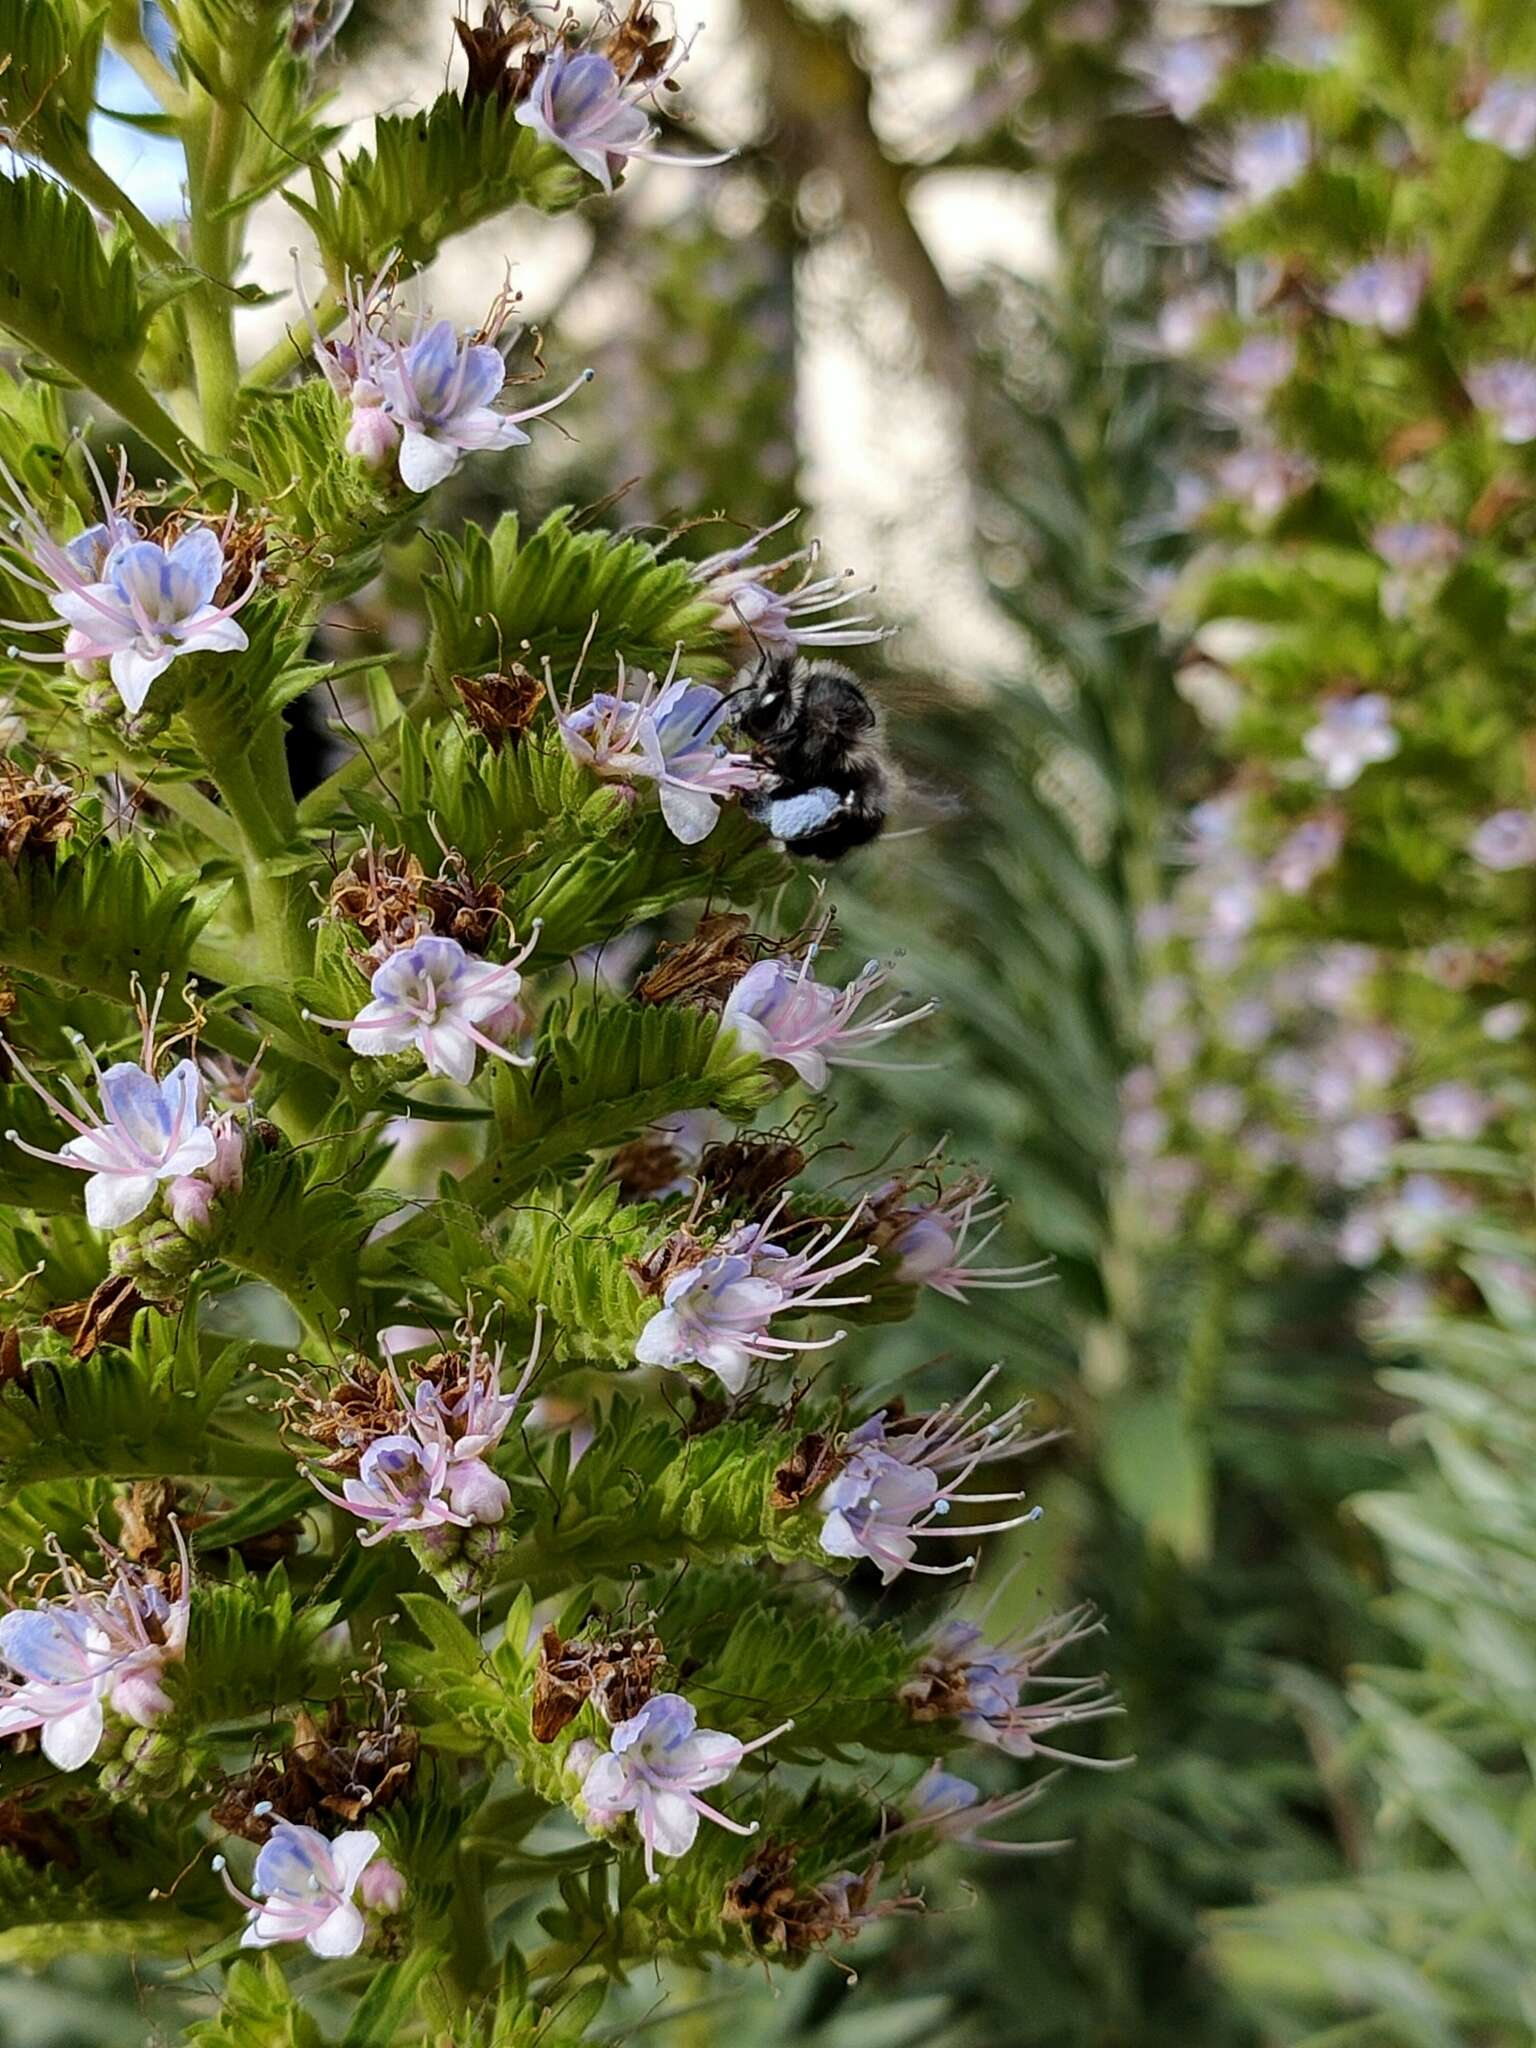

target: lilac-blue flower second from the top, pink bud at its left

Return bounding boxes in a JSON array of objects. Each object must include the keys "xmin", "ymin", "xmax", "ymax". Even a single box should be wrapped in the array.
[{"xmin": 376, "ymin": 319, "xmax": 594, "ymax": 492}]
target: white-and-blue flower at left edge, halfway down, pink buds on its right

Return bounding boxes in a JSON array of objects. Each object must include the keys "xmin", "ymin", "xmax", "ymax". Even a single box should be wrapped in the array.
[{"xmin": 6, "ymin": 1049, "xmax": 219, "ymax": 1231}]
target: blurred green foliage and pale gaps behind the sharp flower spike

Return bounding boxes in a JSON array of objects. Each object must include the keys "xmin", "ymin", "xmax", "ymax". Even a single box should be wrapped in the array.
[{"xmin": 12, "ymin": 0, "xmax": 1536, "ymax": 2048}]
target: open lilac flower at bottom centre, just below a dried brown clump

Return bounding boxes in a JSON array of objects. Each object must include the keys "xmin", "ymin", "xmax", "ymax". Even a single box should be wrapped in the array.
[{"xmin": 582, "ymin": 1692, "xmax": 795, "ymax": 1880}]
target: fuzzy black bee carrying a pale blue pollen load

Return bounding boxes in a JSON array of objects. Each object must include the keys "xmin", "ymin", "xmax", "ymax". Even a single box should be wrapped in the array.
[{"xmin": 733, "ymin": 655, "xmax": 891, "ymax": 860}]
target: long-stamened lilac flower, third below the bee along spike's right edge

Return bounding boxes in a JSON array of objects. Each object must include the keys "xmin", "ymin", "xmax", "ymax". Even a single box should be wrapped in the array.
[{"xmin": 817, "ymin": 1366, "xmax": 1042, "ymax": 1585}]
